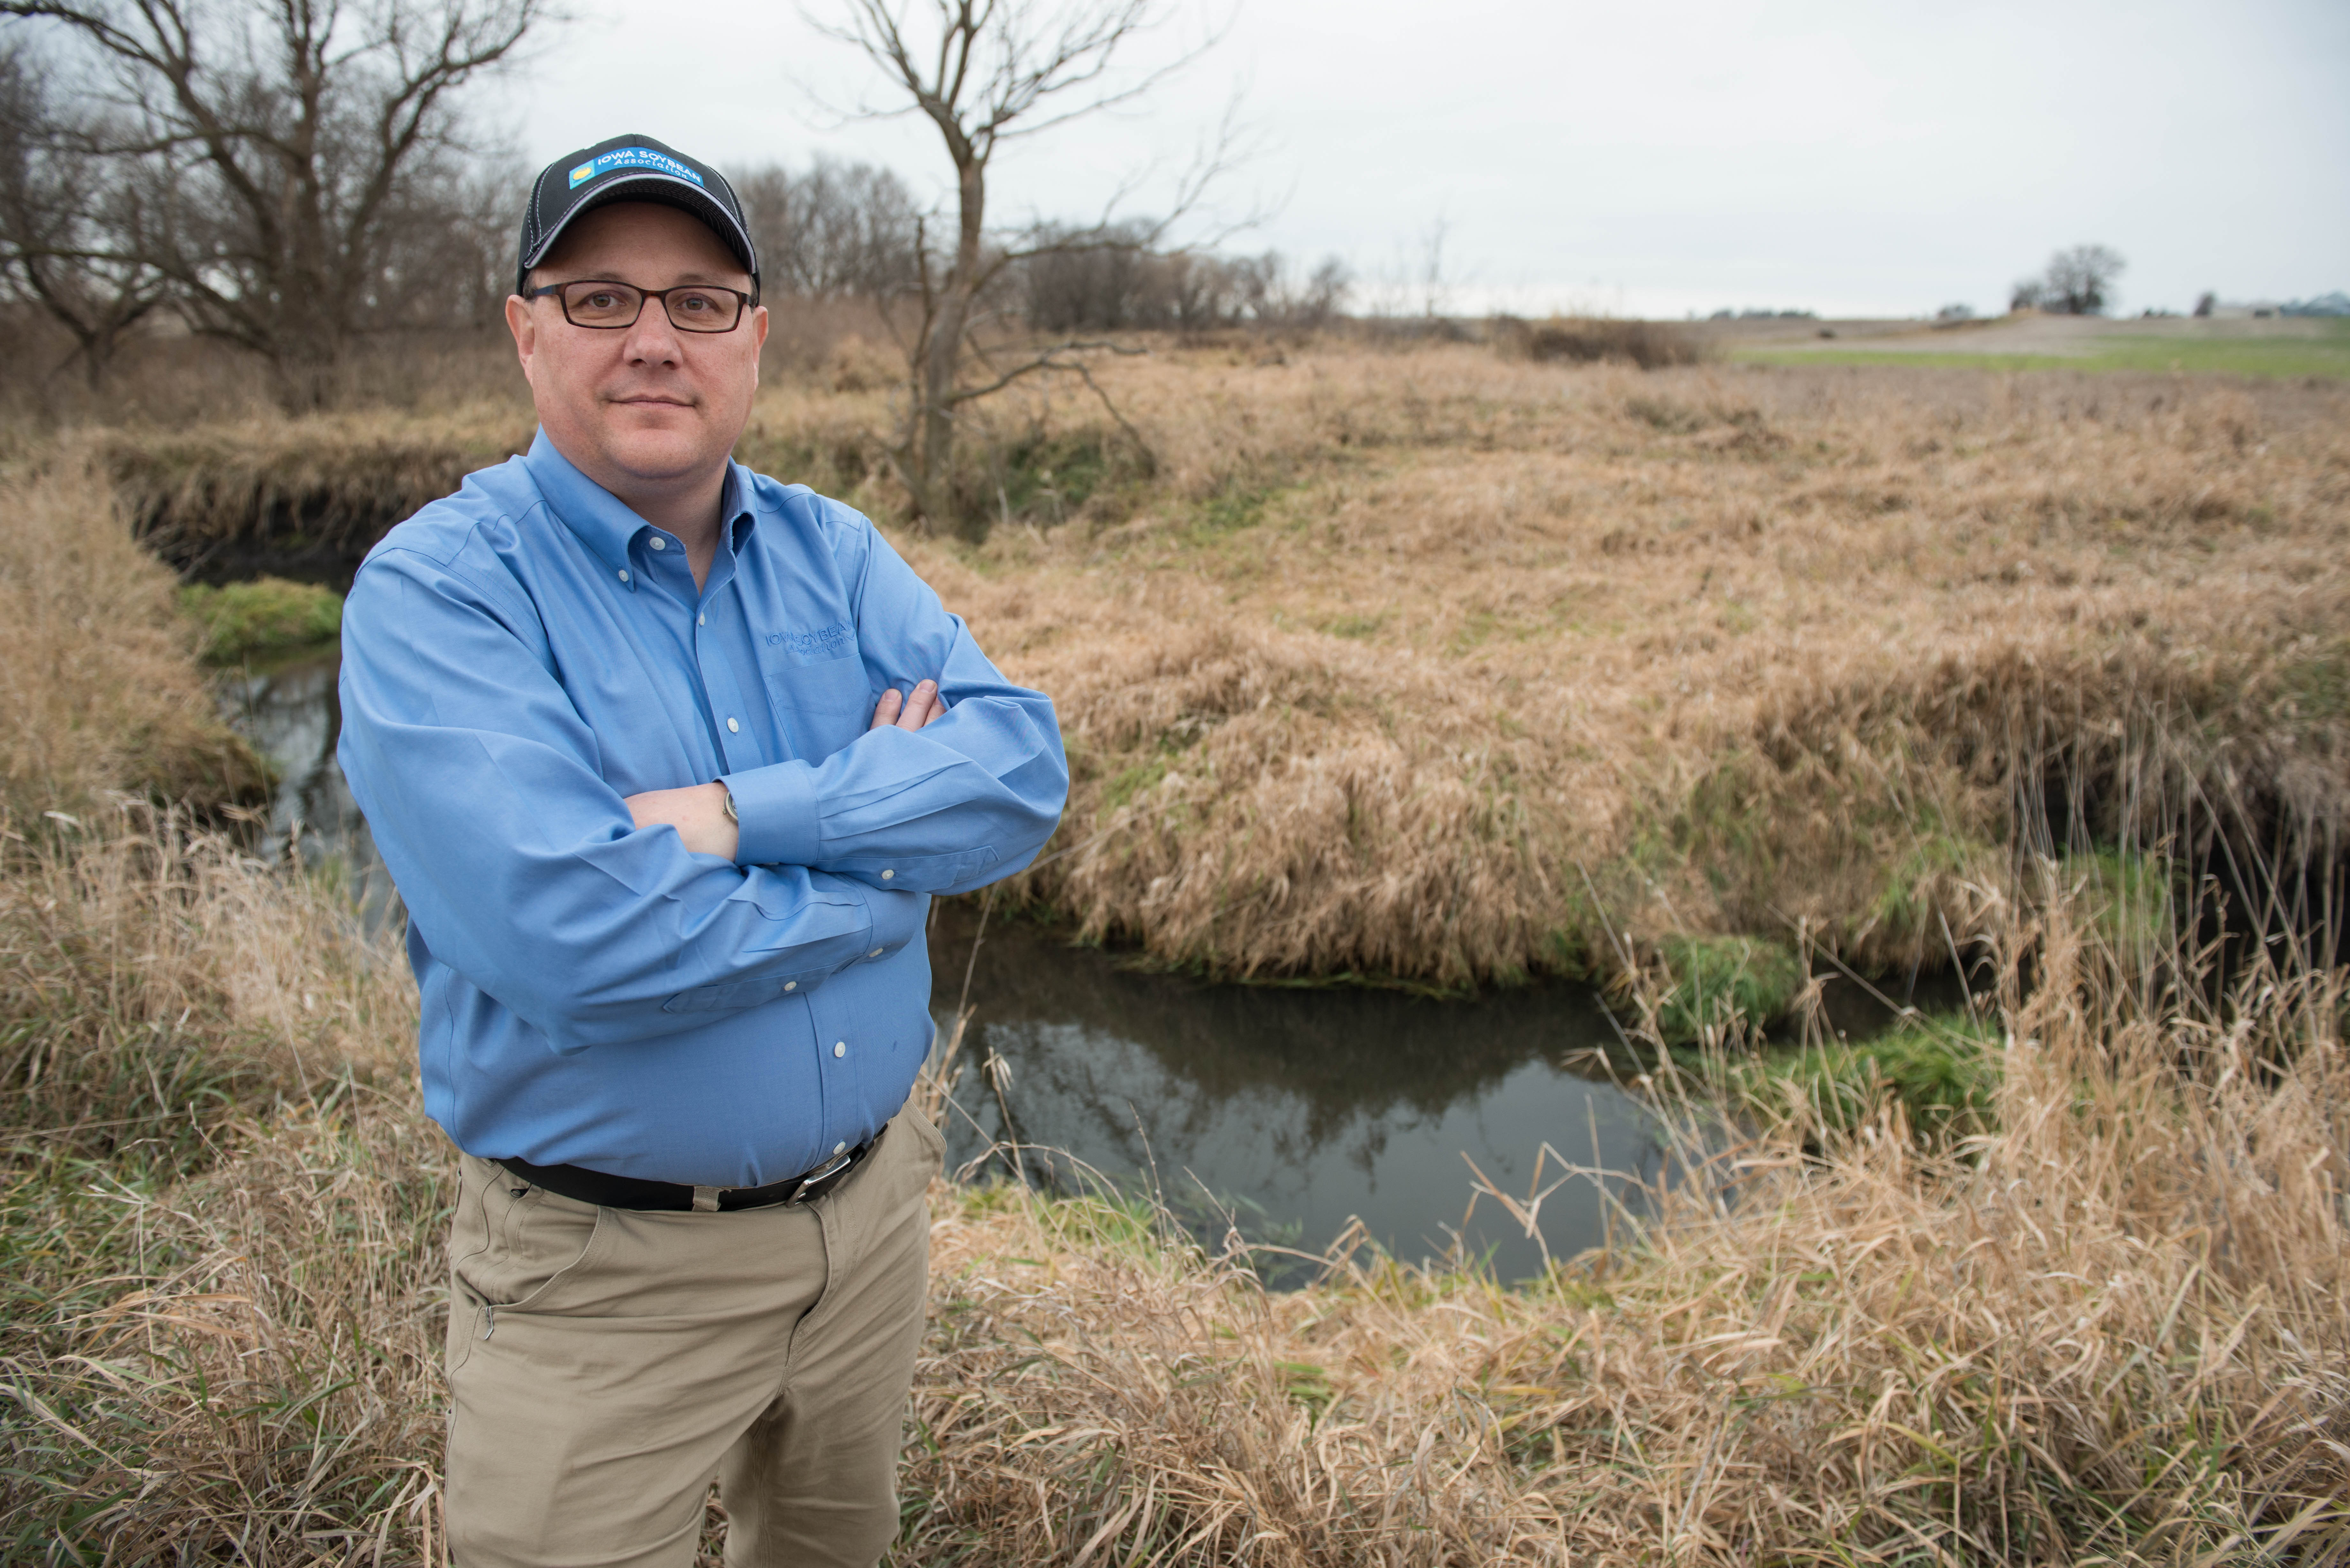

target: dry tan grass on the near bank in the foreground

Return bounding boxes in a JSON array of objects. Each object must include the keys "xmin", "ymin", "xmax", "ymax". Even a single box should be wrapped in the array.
[{"xmin": 0, "ymin": 830, "xmax": 2350, "ymax": 1566}]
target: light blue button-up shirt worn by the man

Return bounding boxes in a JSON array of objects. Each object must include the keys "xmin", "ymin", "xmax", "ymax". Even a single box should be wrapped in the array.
[{"xmin": 336, "ymin": 433, "xmax": 1069, "ymax": 1187}]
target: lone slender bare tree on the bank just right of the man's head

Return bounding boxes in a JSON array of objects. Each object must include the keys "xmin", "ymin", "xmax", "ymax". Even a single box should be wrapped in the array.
[{"xmin": 811, "ymin": 0, "xmax": 1232, "ymax": 529}]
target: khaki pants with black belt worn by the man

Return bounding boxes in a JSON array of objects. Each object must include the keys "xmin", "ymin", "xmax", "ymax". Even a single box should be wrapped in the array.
[{"xmin": 446, "ymin": 1105, "xmax": 945, "ymax": 1568}]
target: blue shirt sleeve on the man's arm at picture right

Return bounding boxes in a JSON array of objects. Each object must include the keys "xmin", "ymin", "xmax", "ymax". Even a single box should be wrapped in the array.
[{"xmin": 724, "ymin": 517, "xmax": 1069, "ymax": 893}]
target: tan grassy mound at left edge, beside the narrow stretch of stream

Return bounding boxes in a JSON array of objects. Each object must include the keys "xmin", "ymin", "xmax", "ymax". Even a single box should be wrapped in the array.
[{"xmin": 0, "ymin": 449, "xmax": 261, "ymax": 823}]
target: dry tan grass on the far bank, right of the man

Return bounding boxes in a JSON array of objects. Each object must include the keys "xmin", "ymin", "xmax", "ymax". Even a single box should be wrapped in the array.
[{"xmin": 883, "ymin": 348, "xmax": 2350, "ymax": 983}]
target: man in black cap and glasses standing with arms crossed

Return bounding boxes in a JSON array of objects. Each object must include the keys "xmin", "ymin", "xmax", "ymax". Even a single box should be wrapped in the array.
[{"xmin": 338, "ymin": 136, "xmax": 1069, "ymax": 1568}]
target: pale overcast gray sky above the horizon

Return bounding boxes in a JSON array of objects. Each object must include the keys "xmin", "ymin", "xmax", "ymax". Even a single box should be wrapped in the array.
[{"xmin": 514, "ymin": 0, "xmax": 2350, "ymax": 315}]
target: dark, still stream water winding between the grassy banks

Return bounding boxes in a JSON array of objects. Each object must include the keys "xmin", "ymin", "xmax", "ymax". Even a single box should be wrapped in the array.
[{"xmin": 221, "ymin": 651, "xmax": 1927, "ymax": 1279}]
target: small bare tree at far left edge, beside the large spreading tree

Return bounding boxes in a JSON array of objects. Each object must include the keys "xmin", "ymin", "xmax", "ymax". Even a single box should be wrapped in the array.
[{"xmin": 0, "ymin": 39, "xmax": 169, "ymax": 388}]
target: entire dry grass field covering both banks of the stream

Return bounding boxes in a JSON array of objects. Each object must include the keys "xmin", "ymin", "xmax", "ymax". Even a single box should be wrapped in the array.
[{"xmin": 0, "ymin": 343, "xmax": 2350, "ymax": 1566}]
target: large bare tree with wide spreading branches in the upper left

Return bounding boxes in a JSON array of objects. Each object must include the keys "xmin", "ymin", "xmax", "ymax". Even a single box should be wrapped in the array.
[{"xmin": 0, "ymin": 0, "xmax": 548, "ymax": 407}]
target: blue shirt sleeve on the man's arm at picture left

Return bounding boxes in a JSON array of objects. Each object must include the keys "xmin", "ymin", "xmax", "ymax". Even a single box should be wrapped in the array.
[{"xmin": 338, "ymin": 550, "xmax": 923, "ymax": 1051}]
